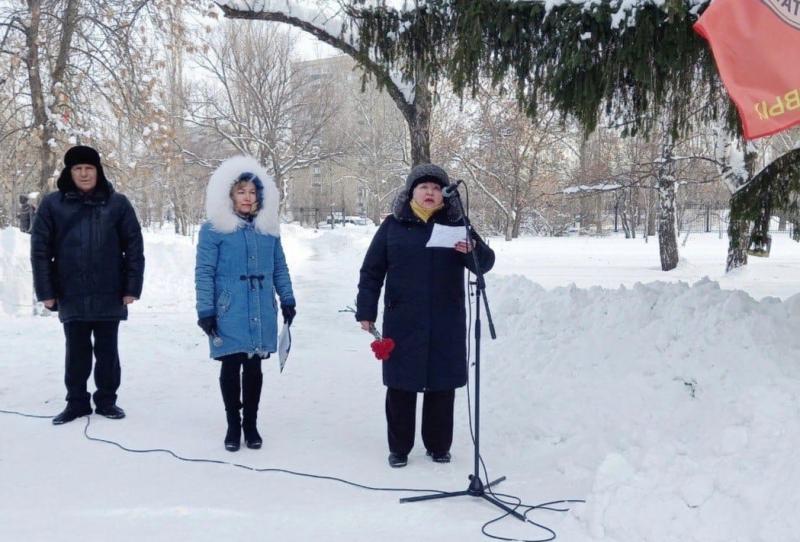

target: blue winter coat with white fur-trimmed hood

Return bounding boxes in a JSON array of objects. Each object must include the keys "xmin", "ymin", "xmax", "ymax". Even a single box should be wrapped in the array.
[{"xmin": 195, "ymin": 157, "xmax": 295, "ymax": 358}]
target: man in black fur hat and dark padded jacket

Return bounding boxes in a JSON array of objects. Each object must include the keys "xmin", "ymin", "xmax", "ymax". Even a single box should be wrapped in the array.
[{"xmin": 31, "ymin": 146, "xmax": 144, "ymax": 425}]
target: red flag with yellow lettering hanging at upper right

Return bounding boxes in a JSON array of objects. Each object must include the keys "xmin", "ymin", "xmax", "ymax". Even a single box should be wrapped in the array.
[{"xmin": 694, "ymin": 0, "xmax": 800, "ymax": 139}]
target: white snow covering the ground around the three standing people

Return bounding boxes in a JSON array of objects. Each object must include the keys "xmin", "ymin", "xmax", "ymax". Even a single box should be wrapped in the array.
[{"xmin": 0, "ymin": 226, "xmax": 800, "ymax": 542}]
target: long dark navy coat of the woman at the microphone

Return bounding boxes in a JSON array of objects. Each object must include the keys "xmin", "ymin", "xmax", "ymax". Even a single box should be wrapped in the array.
[{"xmin": 356, "ymin": 197, "xmax": 494, "ymax": 391}]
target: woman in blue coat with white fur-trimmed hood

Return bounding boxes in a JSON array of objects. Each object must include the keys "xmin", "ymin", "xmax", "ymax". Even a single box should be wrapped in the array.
[{"xmin": 195, "ymin": 156, "xmax": 296, "ymax": 452}]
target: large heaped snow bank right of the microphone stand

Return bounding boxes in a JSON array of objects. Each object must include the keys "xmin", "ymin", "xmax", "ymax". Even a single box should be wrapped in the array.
[{"xmin": 486, "ymin": 277, "xmax": 800, "ymax": 542}]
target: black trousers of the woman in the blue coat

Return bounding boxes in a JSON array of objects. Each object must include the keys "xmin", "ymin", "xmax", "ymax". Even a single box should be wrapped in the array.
[{"xmin": 218, "ymin": 353, "xmax": 264, "ymax": 426}]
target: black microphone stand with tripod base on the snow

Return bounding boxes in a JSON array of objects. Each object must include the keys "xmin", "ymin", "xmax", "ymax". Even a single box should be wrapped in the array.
[{"xmin": 400, "ymin": 183, "xmax": 526, "ymax": 521}]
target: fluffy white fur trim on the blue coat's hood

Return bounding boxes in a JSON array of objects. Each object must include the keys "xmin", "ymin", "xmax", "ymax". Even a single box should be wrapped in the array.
[{"xmin": 206, "ymin": 156, "xmax": 280, "ymax": 237}]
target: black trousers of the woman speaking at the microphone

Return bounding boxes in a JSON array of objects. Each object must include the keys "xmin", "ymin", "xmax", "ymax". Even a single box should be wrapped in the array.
[{"xmin": 386, "ymin": 388, "xmax": 456, "ymax": 454}]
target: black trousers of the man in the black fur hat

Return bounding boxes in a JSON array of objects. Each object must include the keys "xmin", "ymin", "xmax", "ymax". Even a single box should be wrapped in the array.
[{"xmin": 64, "ymin": 320, "xmax": 121, "ymax": 407}]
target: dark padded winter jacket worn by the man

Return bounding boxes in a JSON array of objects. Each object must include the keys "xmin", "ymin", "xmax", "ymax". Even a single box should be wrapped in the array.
[{"xmin": 31, "ymin": 172, "xmax": 144, "ymax": 322}]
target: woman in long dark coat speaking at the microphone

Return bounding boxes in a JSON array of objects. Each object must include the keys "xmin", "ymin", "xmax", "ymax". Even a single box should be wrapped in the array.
[{"xmin": 356, "ymin": 164, "xmax": 494, "ymax": 467}]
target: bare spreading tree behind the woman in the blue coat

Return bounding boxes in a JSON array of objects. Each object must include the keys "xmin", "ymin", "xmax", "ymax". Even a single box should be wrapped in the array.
[{"xmin": 186, "ymin": 21, "xmax": 337, "ymax": 210}]
